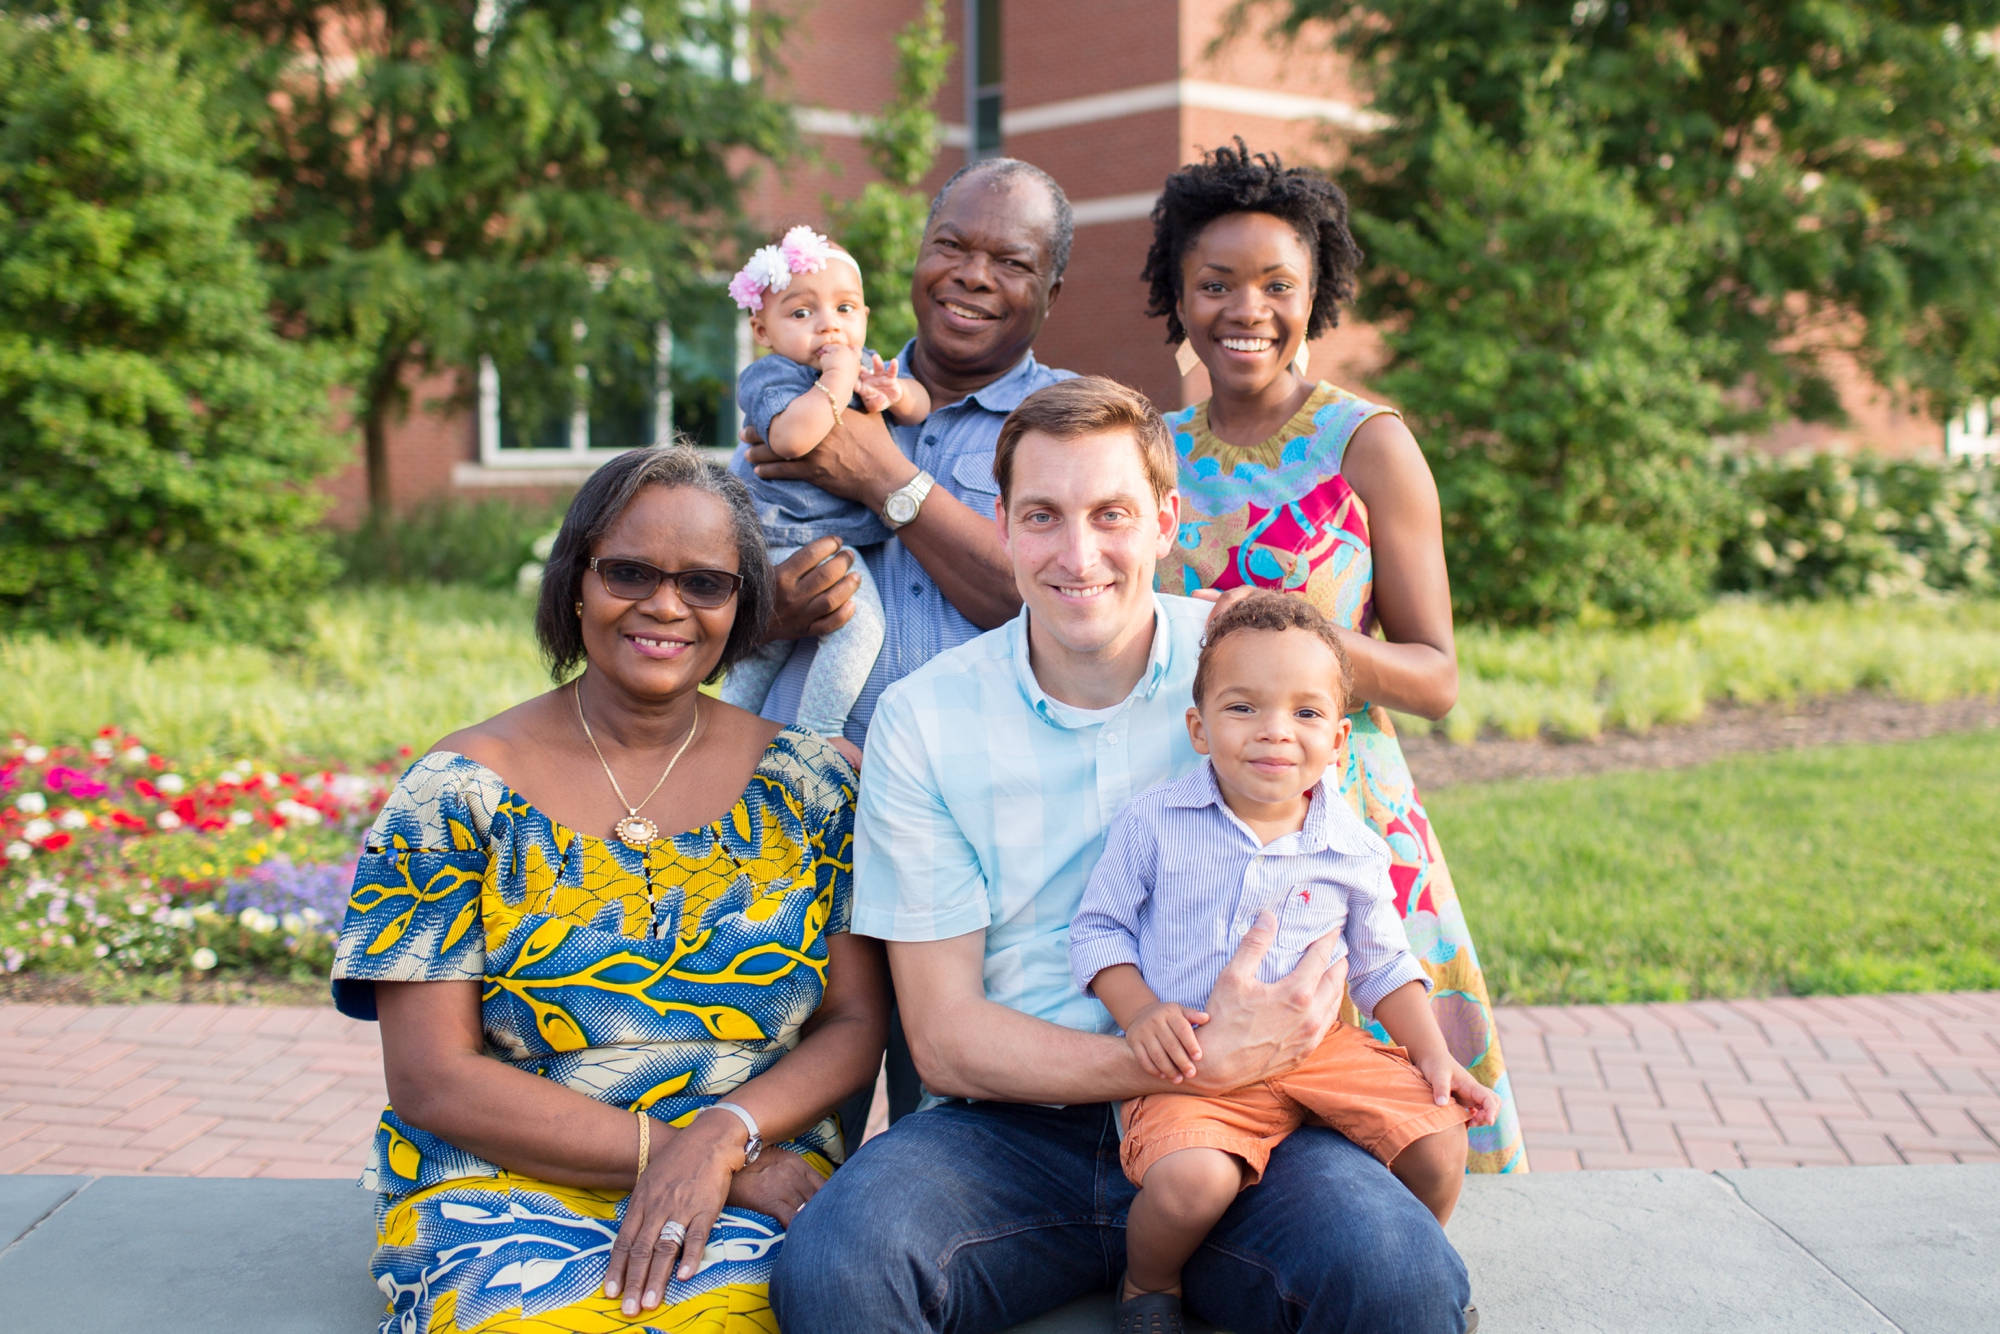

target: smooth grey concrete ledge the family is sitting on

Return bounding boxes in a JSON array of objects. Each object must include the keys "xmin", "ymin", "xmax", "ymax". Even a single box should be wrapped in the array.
[{"xmin": 0, "ymin": 1166, "xmax": 2000, "ymax": 1334}]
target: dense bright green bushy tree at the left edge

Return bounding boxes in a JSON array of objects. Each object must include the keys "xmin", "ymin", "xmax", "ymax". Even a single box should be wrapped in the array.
[{"xmin": 0, "ymin": 14, "xmax": 342, "ymax": 646}]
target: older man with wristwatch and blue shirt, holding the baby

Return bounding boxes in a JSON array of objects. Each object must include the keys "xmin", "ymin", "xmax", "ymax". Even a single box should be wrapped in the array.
[{"xmin": 748, "ymin": 158, "xmax": 1072, "ymax": 746}]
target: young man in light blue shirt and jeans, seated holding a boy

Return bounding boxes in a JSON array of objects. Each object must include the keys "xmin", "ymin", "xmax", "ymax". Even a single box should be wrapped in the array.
[{"xmin": 772, "ymin": 380, "xmax": 1466, "ymax": 1334}]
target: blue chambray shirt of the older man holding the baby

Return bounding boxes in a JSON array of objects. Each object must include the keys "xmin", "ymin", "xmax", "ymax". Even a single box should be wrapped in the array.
[{"xmin": 752, "ymin": 340, "xmax": 1072, "ymax": 748}]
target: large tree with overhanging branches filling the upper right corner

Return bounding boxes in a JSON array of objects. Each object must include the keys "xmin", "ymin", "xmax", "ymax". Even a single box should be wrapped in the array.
[{"xmin": 1278, "ymin": 0, "xmax": 2000, "ymax": 426}]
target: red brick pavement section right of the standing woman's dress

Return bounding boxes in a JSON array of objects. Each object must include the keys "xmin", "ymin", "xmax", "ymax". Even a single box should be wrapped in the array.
[{"xmin": 1500, "ymin": 992, "xmax": 2000, "ymax": 1172}]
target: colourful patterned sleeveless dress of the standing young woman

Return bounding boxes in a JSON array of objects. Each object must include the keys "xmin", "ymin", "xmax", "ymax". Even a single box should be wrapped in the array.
[{"xmin": 1158, "ymin": 384, "xmax": 1528, "ymax": 1172}]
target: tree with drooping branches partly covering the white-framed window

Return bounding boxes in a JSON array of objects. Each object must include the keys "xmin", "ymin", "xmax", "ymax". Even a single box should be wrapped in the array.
[{"xmin": 176, "ymin": 0, "xmax": 790, "ymax": 512}]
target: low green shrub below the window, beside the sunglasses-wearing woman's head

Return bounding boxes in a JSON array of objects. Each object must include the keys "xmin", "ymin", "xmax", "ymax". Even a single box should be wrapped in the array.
[{"xmin": 334, "ymin": 498, "xmax": 570, "ymax": 588}]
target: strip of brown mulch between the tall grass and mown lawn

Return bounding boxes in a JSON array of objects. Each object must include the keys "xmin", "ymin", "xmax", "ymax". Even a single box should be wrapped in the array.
[{"xmin": 1402, "ymin": 690, "xmax": 2000, "ymax": 790}]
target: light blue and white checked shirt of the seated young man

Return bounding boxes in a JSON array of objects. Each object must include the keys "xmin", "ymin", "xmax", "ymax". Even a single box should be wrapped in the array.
[{"xmin": 854, "ymin": 594, "xmax": 1208, "ymax": 1032}]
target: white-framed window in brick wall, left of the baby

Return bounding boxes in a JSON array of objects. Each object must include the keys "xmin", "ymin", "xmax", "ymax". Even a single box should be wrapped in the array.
[{"xmin": 480, "ymin": 284, "xmax": 748, "ymax": 468}]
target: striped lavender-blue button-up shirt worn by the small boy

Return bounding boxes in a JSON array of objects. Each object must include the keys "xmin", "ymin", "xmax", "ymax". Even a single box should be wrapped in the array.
[{"xmin": 1070, "ymin": 760, "xmax": 1430, "ymax": 1020}]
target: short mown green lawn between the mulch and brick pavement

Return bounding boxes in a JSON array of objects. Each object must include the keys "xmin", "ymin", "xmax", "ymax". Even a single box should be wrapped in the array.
[{"xmin": 1426, "ymin": 732, "xmax": 2000, "ymax": 1004}]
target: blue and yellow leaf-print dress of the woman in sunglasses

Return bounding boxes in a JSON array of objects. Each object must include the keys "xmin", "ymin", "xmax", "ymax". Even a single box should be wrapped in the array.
[{"xmin": 334, "ymin": 728, "xmax": 854, "ymax": 1334}]
